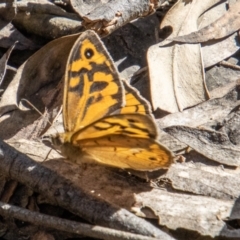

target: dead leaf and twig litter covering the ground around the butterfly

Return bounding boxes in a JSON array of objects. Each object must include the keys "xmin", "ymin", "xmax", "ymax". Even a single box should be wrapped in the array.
[{"xmin": 0, "ymin": 0, "xmax": 240, "ymax": 240}]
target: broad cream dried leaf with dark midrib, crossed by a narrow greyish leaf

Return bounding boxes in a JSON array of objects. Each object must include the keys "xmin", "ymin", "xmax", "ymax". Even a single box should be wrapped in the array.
[{"xmin": 147, "ymin": 0, "xmax": 218, "ymax": 112}]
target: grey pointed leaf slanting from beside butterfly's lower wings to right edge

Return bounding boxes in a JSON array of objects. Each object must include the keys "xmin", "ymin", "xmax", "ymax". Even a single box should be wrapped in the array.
[{"xmin": 164, "ymin": 126, "xmax": 240, "ymax": 167}]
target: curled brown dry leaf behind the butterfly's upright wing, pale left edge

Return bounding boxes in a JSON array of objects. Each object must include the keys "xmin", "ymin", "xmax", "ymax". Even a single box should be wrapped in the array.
[{"xmin": 0, "ymin": 35, "xmax": 79, "ymax": 116}]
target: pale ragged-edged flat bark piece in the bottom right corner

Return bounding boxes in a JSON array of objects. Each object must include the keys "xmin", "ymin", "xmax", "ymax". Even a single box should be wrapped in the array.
[{"xmin": 134, "ymin": 189, "xmax": 239, "ymax": 237}]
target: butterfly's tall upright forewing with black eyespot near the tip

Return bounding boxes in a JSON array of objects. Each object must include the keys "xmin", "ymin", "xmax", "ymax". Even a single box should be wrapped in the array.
[{"xmin": 63, "ymin": 31, "xmax": 124, "ymax": 131}]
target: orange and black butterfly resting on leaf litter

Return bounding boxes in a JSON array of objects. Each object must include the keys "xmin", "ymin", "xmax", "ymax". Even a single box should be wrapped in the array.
[{"xmin": 51, "ymin": 30, "xmax": 173, "ymax": 171}]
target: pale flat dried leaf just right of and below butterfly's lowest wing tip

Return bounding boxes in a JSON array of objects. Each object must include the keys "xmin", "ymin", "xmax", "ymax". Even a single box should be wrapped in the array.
[{"xmin": 164, "ymin": 162, "xmax": 240, "ymax": 200}]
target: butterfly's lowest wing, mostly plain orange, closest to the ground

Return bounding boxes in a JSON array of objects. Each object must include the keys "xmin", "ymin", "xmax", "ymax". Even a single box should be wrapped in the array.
[{"xmin": 74, "ymin": 135, "xmax": 172, "ymax": 171}]
